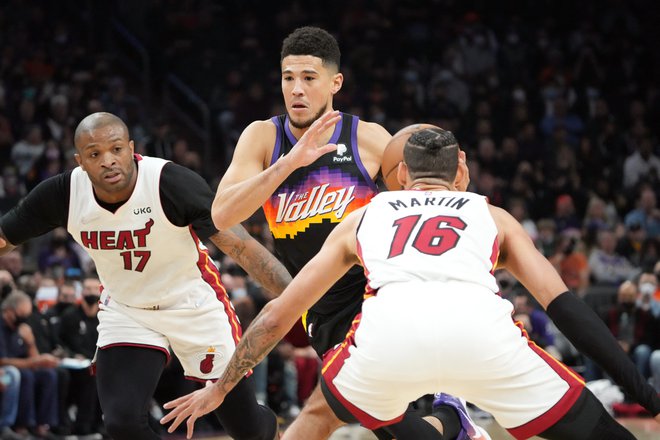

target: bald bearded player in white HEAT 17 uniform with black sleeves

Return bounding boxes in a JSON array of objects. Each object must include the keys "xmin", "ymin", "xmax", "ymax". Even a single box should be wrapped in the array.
[{"xmin": 0, "ymin": 113, "xmax": 290, "ymax": 440}]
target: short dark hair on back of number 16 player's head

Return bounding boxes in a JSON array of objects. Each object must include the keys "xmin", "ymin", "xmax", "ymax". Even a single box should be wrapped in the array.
[{"xmin": 403, "ymin": 128, "xmax": 458, "ymax": 182}]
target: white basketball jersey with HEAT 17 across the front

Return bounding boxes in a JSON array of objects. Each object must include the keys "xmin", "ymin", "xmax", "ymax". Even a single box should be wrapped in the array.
[{"xmin": 68, "ymin": 156, "xmax": 225, "ymax": 309}]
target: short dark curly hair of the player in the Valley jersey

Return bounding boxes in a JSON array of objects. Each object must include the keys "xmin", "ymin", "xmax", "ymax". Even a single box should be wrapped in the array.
[{"xmin": 280, "ymin": 26, "xmax": 341, "ymax": 70}]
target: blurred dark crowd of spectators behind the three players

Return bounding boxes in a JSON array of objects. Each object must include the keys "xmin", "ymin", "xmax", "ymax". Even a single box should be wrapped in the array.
[{"xmin": 0, "ymin": 0, "xmax": 660, "ymax": 438}]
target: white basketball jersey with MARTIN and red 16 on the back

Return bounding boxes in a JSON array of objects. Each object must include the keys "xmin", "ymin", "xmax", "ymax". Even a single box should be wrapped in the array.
[{"xmin": 357, "ymin": 191, "xmax": 498, "ymax": 292}]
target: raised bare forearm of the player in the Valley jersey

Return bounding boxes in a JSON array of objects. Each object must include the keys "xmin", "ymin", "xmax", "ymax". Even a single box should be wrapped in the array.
[{"xmin": 211, "ymin": 157, "xmax": 295, "ymax": 230}]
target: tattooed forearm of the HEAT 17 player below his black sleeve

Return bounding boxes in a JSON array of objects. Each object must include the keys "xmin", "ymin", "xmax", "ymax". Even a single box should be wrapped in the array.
[{"xmin": 211, "ymin": 225, "xmax": 291, "ymax": 295}]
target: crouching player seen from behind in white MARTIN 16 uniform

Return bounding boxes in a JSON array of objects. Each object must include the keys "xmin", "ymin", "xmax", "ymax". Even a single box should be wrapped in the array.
[{"xmin": 165, "ymin": 125, "xmax": 660, "ymax": 440}]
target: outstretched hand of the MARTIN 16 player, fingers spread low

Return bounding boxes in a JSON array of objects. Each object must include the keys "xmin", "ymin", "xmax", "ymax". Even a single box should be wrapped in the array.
[{"xmin": 160, "ymin": 380, "xmax": 226, "ymax": 439}]
